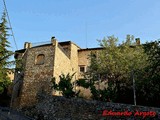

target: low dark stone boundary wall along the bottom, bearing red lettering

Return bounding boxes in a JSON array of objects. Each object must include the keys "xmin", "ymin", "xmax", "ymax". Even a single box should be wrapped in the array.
[{"xmin": 22, "ymin": 94, "xmax": 160, "ymax": 120}]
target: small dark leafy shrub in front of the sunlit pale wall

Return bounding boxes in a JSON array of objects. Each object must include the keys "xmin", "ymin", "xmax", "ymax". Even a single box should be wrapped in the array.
[{"xmin": 51, "ymin": 73, "xmax": 80, "ymax": 98}]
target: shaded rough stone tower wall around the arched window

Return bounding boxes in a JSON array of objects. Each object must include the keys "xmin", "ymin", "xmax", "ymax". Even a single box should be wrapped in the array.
[{"xmin": 19, "ymin": 45, "xmax": 55, "ymax": 107}]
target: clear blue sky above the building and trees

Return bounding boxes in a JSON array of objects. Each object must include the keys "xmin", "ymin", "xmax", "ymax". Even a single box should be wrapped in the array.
[{"xmin": 0, "ymin": 0, "xmax": 160, "ymax": 50}]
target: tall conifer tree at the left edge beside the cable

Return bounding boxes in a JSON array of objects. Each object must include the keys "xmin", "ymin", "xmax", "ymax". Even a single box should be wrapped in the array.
[{"xmin": 0, "ymin": 11, "xmax": 13, "ymax": 93}]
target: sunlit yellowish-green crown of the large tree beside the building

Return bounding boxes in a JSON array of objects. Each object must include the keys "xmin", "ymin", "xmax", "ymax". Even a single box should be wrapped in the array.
[{"xmin": 95, "ymin": 36, "xmax": 147, "ymax": 79}]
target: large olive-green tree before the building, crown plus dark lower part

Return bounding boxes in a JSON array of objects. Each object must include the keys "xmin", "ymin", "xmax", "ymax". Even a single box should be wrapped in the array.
[{"xmin": 86, "ymin": 35, "xmax": 147, "ymax": 102}]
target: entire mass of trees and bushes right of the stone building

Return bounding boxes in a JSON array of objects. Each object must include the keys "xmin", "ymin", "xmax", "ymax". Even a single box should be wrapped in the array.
[{"xmin": 87, "ymin": 35, "xmax": 160, "ymax": 106}]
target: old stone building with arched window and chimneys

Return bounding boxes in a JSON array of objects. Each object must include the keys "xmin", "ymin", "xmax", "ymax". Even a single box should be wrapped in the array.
[{"xmin": 11, "ymin": 37, "xmax": 102, "ymax": 108}]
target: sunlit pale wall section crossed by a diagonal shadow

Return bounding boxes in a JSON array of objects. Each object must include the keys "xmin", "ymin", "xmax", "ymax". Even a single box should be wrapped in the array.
[{"xmin": 53, "ymin": 43, "xmax": 78, "ymax": 81}]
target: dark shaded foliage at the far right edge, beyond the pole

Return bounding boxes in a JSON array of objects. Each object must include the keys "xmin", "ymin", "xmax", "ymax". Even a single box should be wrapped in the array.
[{"xmin": 137, "ymin": 40, "xmax": 160, "ymax": 107}]
